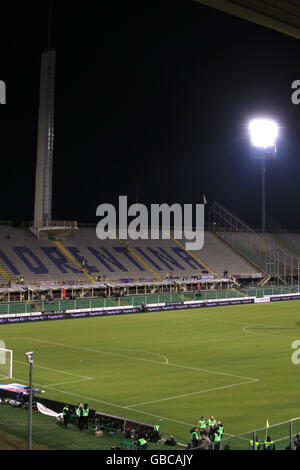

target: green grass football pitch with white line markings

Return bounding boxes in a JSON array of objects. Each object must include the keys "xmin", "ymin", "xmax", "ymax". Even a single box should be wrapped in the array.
[{"xmin": 0, "ymin": 301, "xmax": 300, "ymax": 443}]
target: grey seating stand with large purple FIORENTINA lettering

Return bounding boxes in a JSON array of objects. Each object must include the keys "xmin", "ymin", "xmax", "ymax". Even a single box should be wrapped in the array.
[{"xmin": 0, "ymin": 225, "xmax": 257, "ymax": 284}]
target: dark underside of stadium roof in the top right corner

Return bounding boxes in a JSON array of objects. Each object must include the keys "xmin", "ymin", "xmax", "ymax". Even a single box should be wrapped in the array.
[{"xmin": 196, "ymin": 0, "xmax": 300, "ymax": 39}]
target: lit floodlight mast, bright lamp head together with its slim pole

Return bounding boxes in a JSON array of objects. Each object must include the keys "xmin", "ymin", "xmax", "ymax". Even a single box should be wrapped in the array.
[{"xmin": 249, "ymin": 119, "xmax": 278, "ymax": 232}]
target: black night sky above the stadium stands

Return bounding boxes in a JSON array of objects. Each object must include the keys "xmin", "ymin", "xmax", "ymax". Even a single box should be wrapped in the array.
[{"xmin": 0, "ymin": 0, "xmax": 300, "ymax": 229}]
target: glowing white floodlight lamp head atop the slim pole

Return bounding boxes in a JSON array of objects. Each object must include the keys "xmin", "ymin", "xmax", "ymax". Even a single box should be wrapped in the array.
[{"xmin": 249, "ymin": 119, "xmax": 279, "ymax": 149}]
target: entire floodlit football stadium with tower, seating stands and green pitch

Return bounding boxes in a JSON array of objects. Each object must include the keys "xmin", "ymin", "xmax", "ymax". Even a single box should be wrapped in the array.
[{"xmin": 0, "ymin": 2, "xmax": 300, "ymax": 452}]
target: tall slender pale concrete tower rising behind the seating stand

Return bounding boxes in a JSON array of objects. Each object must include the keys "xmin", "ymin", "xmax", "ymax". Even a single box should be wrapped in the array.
[{"xmin": 34, "ymin": 49, "xmax": 56, "ymax": 230}]
